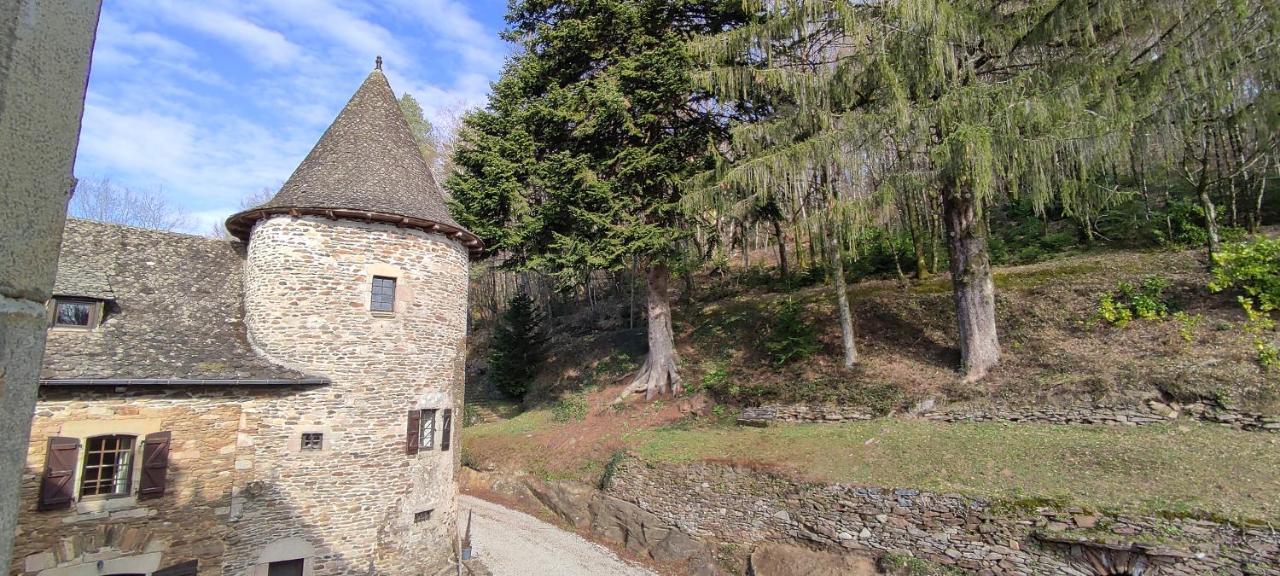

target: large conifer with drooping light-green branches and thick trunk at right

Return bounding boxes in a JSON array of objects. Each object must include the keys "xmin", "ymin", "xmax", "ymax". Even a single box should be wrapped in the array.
[{"xmin": 698, "ymin": 0, "xmax": 1277, "ymax": 380}]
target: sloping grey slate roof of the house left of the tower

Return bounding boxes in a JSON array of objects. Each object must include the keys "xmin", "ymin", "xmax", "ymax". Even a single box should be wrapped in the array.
[{"xmin": 41, "ymin": 219, "xmax": 325, "ymax": 385}]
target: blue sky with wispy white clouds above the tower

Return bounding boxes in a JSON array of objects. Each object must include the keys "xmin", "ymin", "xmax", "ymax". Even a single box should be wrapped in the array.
[{"xmin": 76, "ymin": 0, "xmax": 509, "ymax": 233}]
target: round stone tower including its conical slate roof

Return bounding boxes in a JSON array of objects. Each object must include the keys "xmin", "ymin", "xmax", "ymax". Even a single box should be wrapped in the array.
[{"xmin": 224, "ymin": 63, "xmax": 481, "ymax": 576}]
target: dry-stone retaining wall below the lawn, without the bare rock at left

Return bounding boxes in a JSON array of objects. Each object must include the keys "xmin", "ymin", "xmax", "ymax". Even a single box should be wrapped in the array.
[{"xmin": 607, "ymin": 460, "xmax": 1280, "ymax": 576}]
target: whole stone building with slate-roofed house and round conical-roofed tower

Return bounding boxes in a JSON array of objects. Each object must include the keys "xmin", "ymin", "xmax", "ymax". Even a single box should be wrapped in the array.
[{"xmin": 10, "ymin": 64, "xmax": 481, "ymax": 576}]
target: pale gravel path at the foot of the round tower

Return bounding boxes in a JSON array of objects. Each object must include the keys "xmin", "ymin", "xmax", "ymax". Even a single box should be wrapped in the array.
[{"xmin": 458, "ymin": 495, "xmax": 657, "ymax": 576}]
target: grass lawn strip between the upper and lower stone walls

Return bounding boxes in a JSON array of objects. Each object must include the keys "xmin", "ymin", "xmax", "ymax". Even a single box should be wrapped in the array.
[{"xmin": 463, "ymin": 410, "xmax": 1280, "ymax": 522}]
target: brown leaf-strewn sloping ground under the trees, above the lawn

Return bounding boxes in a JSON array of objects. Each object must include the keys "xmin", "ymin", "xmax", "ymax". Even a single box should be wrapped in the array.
[{"xmin": 501, "ymin": 245, "xmax": 1280, "ymax": 413}]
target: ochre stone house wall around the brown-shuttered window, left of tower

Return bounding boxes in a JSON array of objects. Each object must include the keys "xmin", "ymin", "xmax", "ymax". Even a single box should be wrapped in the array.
[{"xmin": 10, "ymin": 388, "xmax": 253, "ymax": 576}]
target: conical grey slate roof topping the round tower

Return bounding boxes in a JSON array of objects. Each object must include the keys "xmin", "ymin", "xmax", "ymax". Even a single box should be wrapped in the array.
[{"xmin": 227, "ymin": 63, "xmax": 484, "ymax": 256}]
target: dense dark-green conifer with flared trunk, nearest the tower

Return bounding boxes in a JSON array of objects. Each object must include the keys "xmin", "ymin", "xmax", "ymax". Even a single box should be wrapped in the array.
[{"xmin": 448, "ymin": 0, "xmax": 739, "ymax": 398}]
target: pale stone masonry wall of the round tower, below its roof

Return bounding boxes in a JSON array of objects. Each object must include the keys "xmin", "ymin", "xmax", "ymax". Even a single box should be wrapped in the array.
[{"xmin": 235, "ymin": 216, "xmax": 468, "ymax": 576}]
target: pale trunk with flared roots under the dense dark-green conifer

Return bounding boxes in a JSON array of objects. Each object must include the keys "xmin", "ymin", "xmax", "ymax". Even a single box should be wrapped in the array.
[{"xmin": 627, "ymin": 262, "xmax": 681, "ymax": 399}]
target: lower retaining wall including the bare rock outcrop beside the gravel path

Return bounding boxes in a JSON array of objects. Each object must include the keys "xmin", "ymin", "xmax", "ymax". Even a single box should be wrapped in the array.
[{"xmin": 462, "ymin": 458, "xmax": 1280, "ymax": 576}]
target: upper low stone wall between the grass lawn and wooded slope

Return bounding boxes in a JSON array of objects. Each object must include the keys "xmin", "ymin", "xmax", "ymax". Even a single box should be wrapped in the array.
[{"xmin": 739, "ymin": 399, "xmax": 1280, "ymax": 433}]
